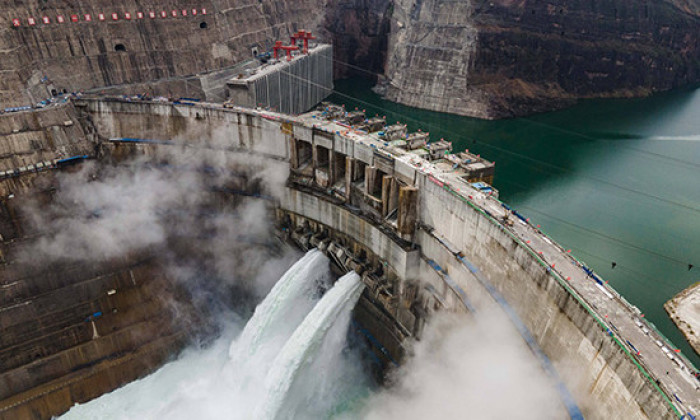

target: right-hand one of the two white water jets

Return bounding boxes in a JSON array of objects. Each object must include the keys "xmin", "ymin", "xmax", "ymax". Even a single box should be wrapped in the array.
[{"xmin": 255, "ymin": 272, "xmax": 364, "ymax": 420}]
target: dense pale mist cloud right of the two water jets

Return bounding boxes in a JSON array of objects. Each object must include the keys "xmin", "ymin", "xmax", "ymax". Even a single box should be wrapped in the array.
[{"xmin": 359, "ymin": 311, "xmax": 566, "ymax": 420}]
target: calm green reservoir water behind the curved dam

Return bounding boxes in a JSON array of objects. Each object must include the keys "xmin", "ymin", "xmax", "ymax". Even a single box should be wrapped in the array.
[{"xmin": 331, "ymin": 79, "xmax": 700, "ymax": 367}]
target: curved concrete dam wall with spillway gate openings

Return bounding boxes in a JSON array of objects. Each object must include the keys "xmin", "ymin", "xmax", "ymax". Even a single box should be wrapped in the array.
[{"xmin": 76, "ymin": 99, "xmax": 683, "ymax": 419}]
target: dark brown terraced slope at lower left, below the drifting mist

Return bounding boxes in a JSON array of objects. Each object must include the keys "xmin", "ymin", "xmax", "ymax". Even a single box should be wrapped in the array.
[{"xmin": 0, "ymin": 167, "xmax": 196, "ymax": 420}]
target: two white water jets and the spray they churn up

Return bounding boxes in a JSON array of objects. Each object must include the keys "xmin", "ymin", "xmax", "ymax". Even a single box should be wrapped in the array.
[{"xmin": 62, "ymin": 250, "xmax": 366, "ymax": 420}]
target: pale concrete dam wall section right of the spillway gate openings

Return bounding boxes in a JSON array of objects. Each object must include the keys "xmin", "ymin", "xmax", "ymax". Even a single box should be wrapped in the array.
[{"xmin": 419, "ymin": 181, "xmax": 676, "ymax": 418}]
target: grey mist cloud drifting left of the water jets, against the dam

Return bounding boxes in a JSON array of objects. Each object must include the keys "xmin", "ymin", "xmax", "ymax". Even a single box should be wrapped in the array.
[{"xmin": 17, "ymin": 135, "xmax": 298, "ymax": 304}]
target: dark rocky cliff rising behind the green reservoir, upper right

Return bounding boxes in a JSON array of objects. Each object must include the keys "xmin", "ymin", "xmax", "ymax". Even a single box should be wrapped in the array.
[{"xmin": 352, "ymin": 0, "xmax": 700, "ymax": 118}]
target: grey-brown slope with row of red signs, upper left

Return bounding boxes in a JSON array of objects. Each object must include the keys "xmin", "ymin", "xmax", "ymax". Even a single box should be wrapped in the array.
[{"xmin": 0, "ymin": 0, "xmax": 323, "ymax": 107}]
